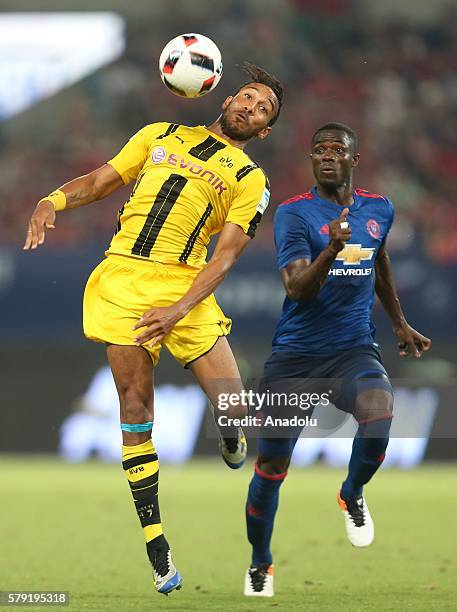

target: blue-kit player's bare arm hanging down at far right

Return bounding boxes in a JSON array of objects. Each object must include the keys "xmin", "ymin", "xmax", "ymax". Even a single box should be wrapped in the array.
[{"xmin": 375, "ymin": 245, "xmax": 432, "ymax": 358}]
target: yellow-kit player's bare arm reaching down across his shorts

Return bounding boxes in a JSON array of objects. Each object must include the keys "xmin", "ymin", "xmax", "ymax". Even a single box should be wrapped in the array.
[{"xmin": 133, "ymin": 223, "xmax": 251, "ymax": 346}]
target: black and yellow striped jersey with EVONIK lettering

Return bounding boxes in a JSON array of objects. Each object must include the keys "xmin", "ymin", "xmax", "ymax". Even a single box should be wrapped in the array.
[{"xmin": 107, "ymin": 123, "xmax": 270, "ymax": 268}]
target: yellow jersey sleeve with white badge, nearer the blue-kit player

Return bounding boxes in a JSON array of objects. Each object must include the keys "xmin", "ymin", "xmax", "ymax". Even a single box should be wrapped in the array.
[{"xmin": 225, "ymin": 164, "xmax": 270, "ymax": 238}]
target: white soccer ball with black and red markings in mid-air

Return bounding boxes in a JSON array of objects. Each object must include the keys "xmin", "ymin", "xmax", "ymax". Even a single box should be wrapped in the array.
[{"xmin": 159, "ymin": 34, "xmax": 222, "ymax": 98}]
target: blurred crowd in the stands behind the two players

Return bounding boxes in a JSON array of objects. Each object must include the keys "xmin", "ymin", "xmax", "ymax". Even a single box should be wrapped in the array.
[{"xmin": 0, "ymin": 0, "xmax": 457, "ymax": 265}]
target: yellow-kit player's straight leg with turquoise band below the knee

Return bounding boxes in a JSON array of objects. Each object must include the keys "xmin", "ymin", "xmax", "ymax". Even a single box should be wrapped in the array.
[{"xmin": 107, "ymin": 344, "xmax": 182, "ymax": 594}]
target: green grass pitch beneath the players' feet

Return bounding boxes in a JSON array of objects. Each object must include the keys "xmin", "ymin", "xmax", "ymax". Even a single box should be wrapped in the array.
[{"xmin": 0, "ymin": 457, "xmax": 457, "ymax": 612}]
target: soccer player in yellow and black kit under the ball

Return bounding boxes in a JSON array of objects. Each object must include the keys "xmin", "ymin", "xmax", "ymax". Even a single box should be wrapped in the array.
[{"xmin": 24, "ymin": 64, "xmax": 283, "ymax": 594}]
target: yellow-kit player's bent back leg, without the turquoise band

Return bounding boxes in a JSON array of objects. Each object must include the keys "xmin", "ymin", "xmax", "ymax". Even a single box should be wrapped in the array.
[{"xmin": 189, "ymin": 336, "xmax": 248, "ymax": 469}]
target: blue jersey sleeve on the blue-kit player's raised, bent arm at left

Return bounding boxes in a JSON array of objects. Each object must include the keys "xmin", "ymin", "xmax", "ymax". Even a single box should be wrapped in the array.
[{"xmin": 274, "ymin": 205, "xmax": 311, "ymax": 269}]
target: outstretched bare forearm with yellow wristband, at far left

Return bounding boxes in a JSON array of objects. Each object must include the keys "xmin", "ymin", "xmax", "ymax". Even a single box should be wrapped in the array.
[{"xmin": 23, "ymin": 164, "xmax": 124, "ymax": 251}]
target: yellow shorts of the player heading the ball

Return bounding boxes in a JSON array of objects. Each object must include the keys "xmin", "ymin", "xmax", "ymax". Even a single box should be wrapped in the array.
[{"xmin": 83, "ymin": 255, "xmax": 232, "ymax": 366}]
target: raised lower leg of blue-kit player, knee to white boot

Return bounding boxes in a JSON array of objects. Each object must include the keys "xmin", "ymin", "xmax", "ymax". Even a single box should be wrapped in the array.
[{"xmin": 337, "ymin": 389, "xmax": 393, "ymax": 547}]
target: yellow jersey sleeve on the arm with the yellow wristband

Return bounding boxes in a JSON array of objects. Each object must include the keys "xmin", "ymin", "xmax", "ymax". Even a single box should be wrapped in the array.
[{"xmin": 107, "ymin": 123, "xmax": 167, "ymax": 185}]
